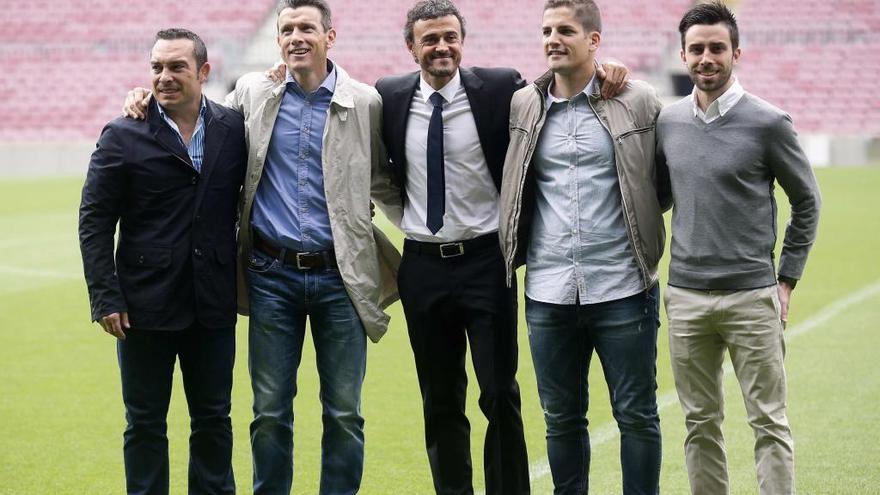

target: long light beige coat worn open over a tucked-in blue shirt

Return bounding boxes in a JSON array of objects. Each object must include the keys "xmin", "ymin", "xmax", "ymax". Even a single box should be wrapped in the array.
[{"xmin": 226, "ymin": 65, "xmax": 403, "ymax": 342}]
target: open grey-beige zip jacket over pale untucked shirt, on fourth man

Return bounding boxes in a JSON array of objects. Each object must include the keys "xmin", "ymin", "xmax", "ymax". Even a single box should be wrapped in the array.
[{"xmin": 498, "ymin": 72, "xmax": 671, "ymax": 289}]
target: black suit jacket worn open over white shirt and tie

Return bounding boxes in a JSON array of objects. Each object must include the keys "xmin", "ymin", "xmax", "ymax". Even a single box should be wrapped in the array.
[{"xmin": 376, "ymin": 67, "xmax": 526, "ymax": 202}]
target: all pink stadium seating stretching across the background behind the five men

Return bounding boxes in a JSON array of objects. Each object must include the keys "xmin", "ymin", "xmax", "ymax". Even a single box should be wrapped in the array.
[{"xmin": 0, "ymin": 0, "xmax": 880, "ymax": 141}]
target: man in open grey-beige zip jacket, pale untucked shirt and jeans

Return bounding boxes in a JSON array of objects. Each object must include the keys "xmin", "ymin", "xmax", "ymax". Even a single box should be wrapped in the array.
[{"xmin": 499, "ymin": 0, "xmax": 664, "ymax": 494}]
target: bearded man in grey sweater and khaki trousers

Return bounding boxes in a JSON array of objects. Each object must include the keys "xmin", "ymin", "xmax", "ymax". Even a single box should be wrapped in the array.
[{"xmin": 657, "ymin": 3, "xmax": 820, "ymax": 495}]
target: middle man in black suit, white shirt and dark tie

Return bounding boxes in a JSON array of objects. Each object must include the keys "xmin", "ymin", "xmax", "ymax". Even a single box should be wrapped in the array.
[{"xmin": 376, "ymin": 0, "xmax": 529, "ymax": 495}]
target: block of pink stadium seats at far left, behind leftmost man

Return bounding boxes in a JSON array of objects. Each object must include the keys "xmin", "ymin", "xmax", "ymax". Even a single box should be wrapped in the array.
[{"xmin": 0, "ymin": 0, "xmax": 274, "ymax": 141}]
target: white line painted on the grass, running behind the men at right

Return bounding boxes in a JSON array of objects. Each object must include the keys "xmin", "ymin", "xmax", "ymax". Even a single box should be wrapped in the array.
[{"xmin": 478, "ymin": 280, "xmax": 880, "ymax": 495}]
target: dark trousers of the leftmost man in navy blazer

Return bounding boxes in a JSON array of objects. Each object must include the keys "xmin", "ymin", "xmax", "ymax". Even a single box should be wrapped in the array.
[{"xmin": 117, "ymin": 324, "xmax": 235, "ymax": 495}]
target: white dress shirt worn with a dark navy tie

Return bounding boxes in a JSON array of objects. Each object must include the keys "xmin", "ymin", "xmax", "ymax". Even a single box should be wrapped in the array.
[{"xmin": 400, "ymin": 72, "xmax": 498, "ymax": 242}]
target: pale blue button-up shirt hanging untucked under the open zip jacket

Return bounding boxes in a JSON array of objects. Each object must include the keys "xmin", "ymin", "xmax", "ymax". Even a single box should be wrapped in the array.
[{"xmin": 526, "ymin": 77, "xmax": 645, "ymax": 304}]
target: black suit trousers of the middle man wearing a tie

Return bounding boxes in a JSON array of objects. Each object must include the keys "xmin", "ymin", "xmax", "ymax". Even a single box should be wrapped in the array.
[{"xmin": 398, "ymin": 238, "xmax": 529, "ymax": 495}]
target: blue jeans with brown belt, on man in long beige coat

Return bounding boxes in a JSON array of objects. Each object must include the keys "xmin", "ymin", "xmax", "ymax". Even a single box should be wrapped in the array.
[{"xmin": 248, "ymin": 251, "xmax": 367, "ymax": 494}]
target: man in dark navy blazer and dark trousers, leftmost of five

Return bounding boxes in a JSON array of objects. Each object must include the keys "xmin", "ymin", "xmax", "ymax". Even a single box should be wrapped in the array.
[{"xmin": 79, "ymin": 29, "xmax": 247, "ymax": 494}]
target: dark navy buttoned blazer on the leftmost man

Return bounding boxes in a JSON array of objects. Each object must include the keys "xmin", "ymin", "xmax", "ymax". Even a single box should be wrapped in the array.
[{"xmin": 79, "ymin": 100, "xmax": 247, "ymax": 330}]
